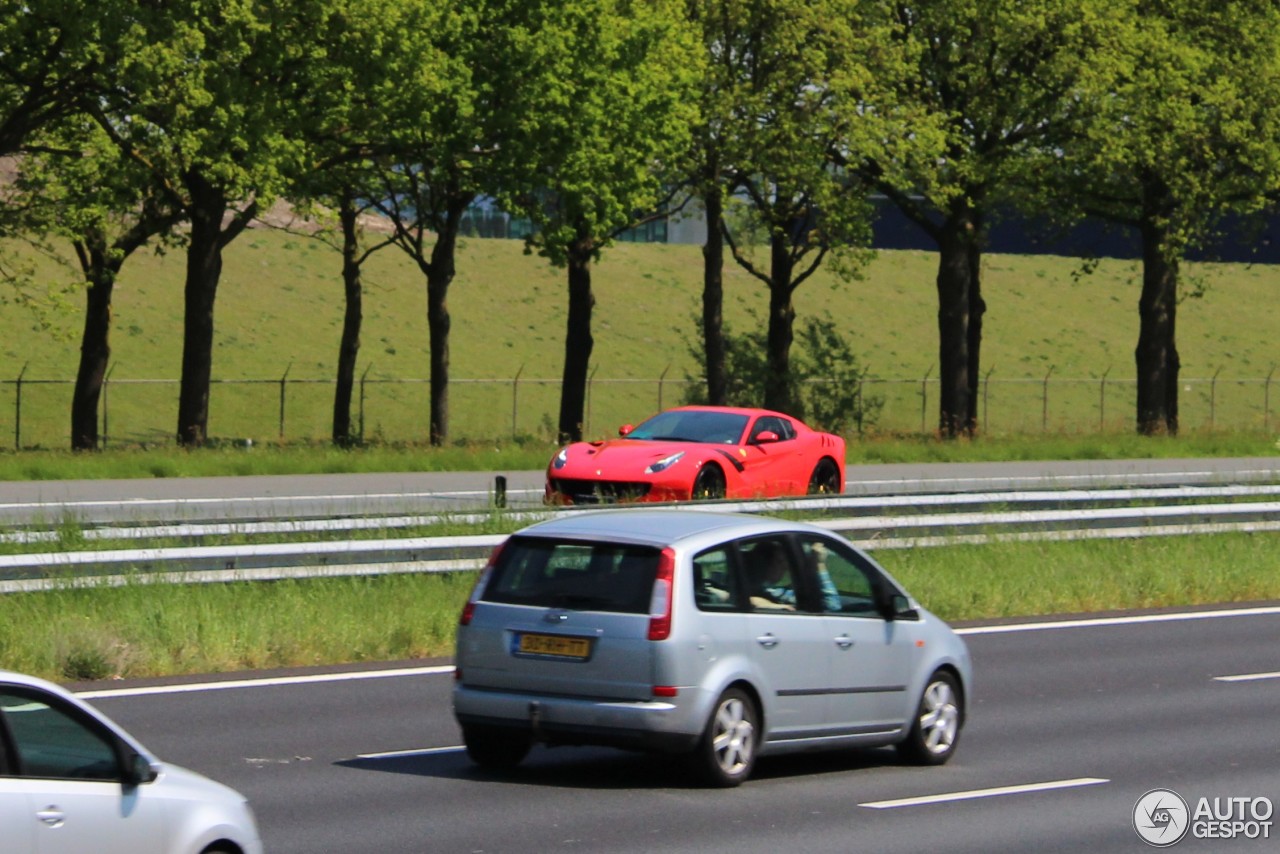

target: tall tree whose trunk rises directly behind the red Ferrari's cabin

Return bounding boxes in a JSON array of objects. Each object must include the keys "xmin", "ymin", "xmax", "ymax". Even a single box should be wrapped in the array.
[{"xmin": 724, "ymin": 0, "xmax": 890, "ymax": 411}]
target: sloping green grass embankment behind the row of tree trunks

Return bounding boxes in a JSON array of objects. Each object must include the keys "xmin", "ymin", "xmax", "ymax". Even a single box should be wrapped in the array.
[{"xmin": 0, "ymin": 230, "xmax": 1280, "ymax": 448}]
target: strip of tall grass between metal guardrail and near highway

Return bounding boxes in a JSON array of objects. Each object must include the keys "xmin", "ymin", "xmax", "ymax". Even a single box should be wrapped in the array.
[{"xmin": 0, "ymin": 534, "xmax": 1280, "ymax": 680}]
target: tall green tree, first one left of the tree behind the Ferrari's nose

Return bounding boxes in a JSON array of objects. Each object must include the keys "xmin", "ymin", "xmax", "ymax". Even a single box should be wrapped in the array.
[{"xmin": 358, "ymin": 0, "xmax": 496, "ymax": 446}]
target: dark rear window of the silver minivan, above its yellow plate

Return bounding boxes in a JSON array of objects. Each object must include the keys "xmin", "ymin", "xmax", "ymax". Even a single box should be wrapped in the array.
[{"xmin": 481, "ymin": 536, "xmax": 660, "ymax": 613}]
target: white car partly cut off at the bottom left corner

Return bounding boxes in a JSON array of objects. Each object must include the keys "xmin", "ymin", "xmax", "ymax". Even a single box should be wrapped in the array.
[{"xmin": 0, "ymin": 670, "xmax": 262, "ymax": 854}]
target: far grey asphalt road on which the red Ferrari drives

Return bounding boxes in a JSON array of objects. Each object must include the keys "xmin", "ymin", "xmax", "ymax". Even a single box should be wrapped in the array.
[{"xmin": 0, "ymin": 455, "xmax": 1280, "ymax": 525}]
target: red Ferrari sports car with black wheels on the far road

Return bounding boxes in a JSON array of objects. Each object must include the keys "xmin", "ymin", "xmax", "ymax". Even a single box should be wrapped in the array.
[{"xmin": 545, "ymin": 406, "xmax": 845, "ymax": 504}]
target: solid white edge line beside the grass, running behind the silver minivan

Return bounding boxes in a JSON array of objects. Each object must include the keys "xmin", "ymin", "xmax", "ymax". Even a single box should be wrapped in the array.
[{"xmin": 78, "ymin": 606, "xmax": 1280, "ymax": 699}]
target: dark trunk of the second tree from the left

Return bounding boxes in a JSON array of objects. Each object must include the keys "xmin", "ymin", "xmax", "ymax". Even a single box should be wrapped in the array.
[{"xmin": 178, "ymin": 173, "xmax": 228, "ymax": 448}]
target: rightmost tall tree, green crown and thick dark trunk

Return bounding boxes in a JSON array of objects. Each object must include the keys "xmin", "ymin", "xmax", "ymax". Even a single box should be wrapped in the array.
[{"xmin": 1042, "ymin": 0, "xmax": 1280, "ymax": 435}]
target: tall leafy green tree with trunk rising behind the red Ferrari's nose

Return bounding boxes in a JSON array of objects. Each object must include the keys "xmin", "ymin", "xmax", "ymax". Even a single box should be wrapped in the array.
[{"xmin": 500, "ymin": 0, "xmax": 701, "ymax": 440}]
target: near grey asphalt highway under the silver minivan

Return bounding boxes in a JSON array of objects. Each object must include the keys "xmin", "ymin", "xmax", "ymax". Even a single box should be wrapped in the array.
[{"xmin": 82, "ymin": 606, "xmax": 1280, "ymax": 854}]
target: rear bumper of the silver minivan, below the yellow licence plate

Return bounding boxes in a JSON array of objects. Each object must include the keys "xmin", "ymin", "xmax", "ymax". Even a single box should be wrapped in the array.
[{"xmin": 453, "ymin": 685, "xmax": 704, "ymax": 753}]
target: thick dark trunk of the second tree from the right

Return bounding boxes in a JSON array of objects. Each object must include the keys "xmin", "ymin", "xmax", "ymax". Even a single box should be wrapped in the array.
[{"xmin": 937, "ymin": 209, "xmax": 972, "ymax": 439}]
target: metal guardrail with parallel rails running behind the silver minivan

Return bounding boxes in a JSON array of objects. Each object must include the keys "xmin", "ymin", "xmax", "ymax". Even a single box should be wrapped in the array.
[{"xmin": 0, "ymin": 485, "xmax": 1280, "ymax": 593}]
